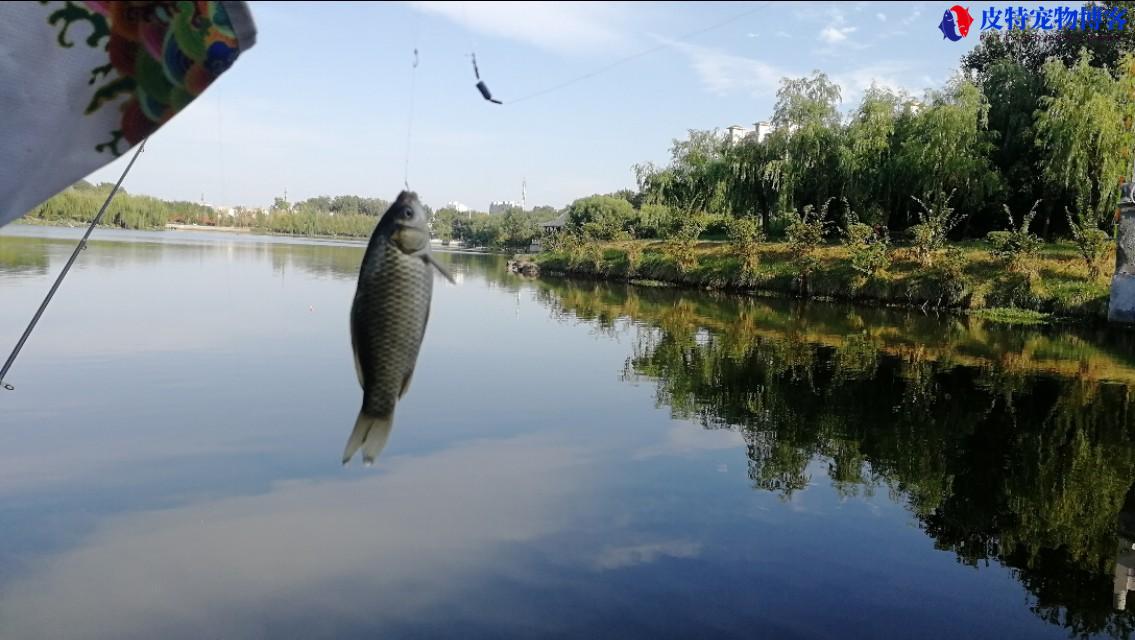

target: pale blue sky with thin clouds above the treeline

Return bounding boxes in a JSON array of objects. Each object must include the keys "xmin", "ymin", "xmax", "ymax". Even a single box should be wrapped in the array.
[{"xmin": 92, "ymin": 2, "xmax": 1016, "ymax": 210}]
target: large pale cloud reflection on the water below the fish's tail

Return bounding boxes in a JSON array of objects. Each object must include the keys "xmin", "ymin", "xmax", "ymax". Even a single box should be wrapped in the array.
[{"xmin": 0, "ymin": 438, "xmax": 590, "ymax": 640}]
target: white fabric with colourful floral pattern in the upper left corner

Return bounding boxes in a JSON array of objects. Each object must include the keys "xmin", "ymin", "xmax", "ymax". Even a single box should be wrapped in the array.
[{"xmin": 0, "ymin": 0, "xmax": 257, "ymax": 226}]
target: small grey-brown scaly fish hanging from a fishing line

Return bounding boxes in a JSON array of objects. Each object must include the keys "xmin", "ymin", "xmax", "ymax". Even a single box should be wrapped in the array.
[{"xmin": 343, "ymin": 191, "xmax": 454, "ymax": 465}]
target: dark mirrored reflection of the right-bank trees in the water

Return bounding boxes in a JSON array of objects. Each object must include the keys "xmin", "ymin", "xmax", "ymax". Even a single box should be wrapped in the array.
[{"xmin": 537, "ymin": 280, "xmax": 1135, "ymax": 638}]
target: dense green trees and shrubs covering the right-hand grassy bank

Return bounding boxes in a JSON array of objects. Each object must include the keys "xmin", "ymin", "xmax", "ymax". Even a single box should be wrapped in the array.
[{"xmin": 537, "ymin": 20, "xmax": 1135, "ymax": 317}]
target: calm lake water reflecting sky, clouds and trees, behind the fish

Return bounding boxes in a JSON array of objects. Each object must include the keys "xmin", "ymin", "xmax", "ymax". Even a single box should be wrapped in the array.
[{"xmin": 0, "ymin": 227, "xmax": 1135, "ymax": 639}]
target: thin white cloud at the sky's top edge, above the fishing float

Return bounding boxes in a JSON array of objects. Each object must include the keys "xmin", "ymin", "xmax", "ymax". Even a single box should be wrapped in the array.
[{"xmin": 410, "ymin": 2, "xmax": 629, "ymax": 53}]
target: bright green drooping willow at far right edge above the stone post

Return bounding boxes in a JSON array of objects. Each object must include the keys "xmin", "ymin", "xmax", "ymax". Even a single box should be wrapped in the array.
[{"xmin": 1036, "ymin": 52, "xmax": 1135, "ymax": 225}]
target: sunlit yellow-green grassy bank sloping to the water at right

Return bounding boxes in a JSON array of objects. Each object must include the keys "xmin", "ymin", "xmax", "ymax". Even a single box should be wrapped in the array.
[{"xmin": 533, "ymin": 241, "xmax": 1110, "ymax": 322}]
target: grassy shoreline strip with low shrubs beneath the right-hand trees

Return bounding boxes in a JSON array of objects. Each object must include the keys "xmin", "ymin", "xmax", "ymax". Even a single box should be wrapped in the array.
[{"xmin": 528, "ymin": 241, "xmax": 1116, "ymax": 330}]
